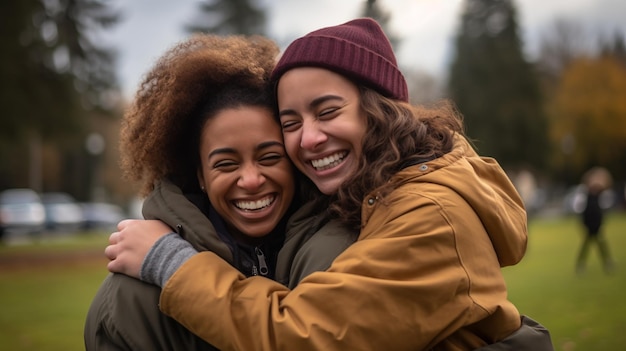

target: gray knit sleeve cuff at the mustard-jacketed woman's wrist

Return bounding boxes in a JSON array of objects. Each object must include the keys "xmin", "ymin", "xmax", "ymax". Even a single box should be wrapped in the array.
[{"xmin": 139, "ymin": 233, "xmax": 198, "ymax": 287}]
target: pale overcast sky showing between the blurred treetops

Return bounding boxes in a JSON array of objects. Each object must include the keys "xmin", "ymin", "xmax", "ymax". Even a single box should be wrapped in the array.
[{"xmin": 102, "ymin": 0, "xmax": 626, "ymax": 98}]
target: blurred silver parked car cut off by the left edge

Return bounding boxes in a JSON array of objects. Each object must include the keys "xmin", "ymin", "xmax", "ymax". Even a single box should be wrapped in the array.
[{"xmin": 0, "ymin": 188, "xmax": 46, "ymax": 235}]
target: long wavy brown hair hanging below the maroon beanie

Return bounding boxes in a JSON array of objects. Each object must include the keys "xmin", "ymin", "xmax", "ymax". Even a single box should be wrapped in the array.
[{"xmin": 330, "ymin": 87, "xmax": 463, "ymax": 229}]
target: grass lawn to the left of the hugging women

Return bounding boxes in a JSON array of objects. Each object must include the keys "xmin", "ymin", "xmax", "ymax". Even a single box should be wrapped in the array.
[{"xmin": 0, "ymin": 235, "xmax": 108, "ymax": 351}]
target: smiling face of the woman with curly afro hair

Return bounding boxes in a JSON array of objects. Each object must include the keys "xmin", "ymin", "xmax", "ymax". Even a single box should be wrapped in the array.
[{"xmin": 198, "ymin": 106, "xmax": 294, "ymax": 241}]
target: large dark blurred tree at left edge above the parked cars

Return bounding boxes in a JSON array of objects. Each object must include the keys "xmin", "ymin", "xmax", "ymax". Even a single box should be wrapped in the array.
[{"xmin": 0, "ymin": 0, "xmax": 119, "ymax": 198}]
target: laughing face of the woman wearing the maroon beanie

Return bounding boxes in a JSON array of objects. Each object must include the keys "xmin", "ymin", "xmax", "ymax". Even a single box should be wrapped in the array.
[{"xmin": 277, "ymin": 67, "xmax": 366, "ymax": 194}]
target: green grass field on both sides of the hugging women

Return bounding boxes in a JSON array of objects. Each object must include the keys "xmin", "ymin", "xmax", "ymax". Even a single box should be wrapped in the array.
[{"xmin": 0, "ymin": 213, "xmax": 626, "ymax": 351}]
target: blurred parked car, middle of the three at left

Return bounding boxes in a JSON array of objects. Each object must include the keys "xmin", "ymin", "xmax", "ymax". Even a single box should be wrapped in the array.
[{"xmin": 41, "ymin": 193, "xmax": 83, "ymax": 232}]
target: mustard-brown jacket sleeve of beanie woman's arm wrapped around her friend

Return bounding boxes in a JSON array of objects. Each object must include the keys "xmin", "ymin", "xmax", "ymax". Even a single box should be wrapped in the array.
[{"xmin": 160, "ymin": 190, "xmax": 520, "ymax": 351}]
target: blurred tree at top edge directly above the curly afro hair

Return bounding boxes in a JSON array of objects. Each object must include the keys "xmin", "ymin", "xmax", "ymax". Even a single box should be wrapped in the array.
[{"xmin": 186, "ymin": 0, "xmax": 266, "ymax": 35}]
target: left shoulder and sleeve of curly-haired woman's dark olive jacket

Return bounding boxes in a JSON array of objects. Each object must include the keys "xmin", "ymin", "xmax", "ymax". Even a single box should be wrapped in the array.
[{"xmin": 84, "ymin": 182, "xmax": 244, "ymax": 351}]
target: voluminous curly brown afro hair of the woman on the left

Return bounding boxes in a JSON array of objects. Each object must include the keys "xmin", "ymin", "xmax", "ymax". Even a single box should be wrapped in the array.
[{"xmin": 120, "ymin": 34, "xmax": 279, "ymax": 196}]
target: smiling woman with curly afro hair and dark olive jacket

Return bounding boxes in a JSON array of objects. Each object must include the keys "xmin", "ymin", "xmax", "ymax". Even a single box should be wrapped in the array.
[{"xmin": 84, "ymin": 35, "xmax": 295, "ymax": 350}]
